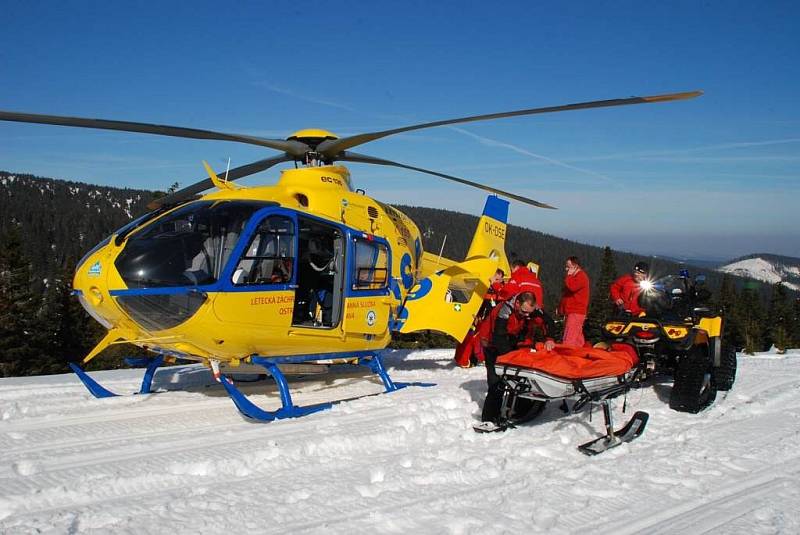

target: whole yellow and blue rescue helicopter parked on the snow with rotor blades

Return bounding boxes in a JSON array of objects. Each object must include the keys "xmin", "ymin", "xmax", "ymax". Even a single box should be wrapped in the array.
[{"xmin": 0, "ymin": 91, "xmax": 702, "ymax": 421}]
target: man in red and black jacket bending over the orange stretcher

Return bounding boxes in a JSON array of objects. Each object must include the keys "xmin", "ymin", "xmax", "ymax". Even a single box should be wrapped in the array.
[{"xmin": 479, "ymin": 292, "xmax": 555, "ymax": 423}]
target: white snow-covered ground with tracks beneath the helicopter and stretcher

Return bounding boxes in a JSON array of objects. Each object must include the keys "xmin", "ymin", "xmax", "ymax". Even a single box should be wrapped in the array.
[{"xmin": 0, "ymin": 350, "xmax": 800, "ymax": 534}]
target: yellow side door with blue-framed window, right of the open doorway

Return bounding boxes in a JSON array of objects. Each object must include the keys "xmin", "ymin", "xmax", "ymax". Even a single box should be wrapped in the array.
[{"xmin": 344, "ymin": 233, "xmax": 392, "ymax": 337}]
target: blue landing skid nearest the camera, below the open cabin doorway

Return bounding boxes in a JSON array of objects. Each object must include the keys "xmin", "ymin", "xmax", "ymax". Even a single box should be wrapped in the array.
[{"xmin": 219, "ymin": 351, "xmax": 436, "ymax": 422}]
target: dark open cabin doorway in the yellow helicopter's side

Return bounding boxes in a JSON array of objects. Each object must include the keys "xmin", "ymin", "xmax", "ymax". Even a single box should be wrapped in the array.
[{"xmin": 292, "ymin": 217, "xmax": 344, "ymax": 329}]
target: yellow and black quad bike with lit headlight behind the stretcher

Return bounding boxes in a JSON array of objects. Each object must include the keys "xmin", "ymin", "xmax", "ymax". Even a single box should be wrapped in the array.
[{"xmin": 603, "ymin": 270, "xmax": 736, "ymax": 413}]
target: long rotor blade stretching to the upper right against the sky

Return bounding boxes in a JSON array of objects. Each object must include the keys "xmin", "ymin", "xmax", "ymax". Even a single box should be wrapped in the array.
[{"xmin": 317, "ymin": 91, "xmax": 703, "ymax": 158}]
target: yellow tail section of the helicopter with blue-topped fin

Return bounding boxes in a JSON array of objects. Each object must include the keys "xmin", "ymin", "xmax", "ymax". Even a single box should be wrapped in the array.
[{"xmin": 394, "ymin": 196, "xmax": 508, "ymax": 340}]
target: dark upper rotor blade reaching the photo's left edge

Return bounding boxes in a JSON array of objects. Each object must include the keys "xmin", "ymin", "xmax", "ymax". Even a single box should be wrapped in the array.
[{"xmin": 0, "ymin": 111, "xmax": 309, "ymax": 158}]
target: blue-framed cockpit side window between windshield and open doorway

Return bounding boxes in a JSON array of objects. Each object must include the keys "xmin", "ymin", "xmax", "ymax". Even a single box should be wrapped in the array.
[{"xmin": 232, "ymin": 216, "xmax": 295, "ymax": 285}]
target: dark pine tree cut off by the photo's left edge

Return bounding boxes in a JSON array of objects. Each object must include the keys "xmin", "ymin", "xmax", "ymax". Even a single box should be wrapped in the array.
[{"xmin": 0, "ymin": 227, "xmax": 41, "ymax": 377}]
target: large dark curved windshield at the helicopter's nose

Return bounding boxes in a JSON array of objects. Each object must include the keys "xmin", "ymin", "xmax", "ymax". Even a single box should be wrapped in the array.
[{"xmin": 115, "ymin": 201, "xmax": 270, "ymax": 288}]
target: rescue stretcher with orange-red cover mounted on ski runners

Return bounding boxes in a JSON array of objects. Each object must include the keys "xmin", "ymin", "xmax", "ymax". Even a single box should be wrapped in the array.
[{"xmin": 495, "ymin": 344, "xmax": 649, "ymax": 455}]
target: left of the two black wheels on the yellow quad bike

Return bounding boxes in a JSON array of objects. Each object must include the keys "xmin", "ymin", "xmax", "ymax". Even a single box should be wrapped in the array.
[{"xmin": 669, "ymin": 345, "xmax": 717, "ymax": 414}]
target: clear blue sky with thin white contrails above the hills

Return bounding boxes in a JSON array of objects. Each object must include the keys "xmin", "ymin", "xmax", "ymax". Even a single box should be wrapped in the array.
[{"xmin": 0, "ymin": 0, "xmax": 800, "ymax": 258}]
